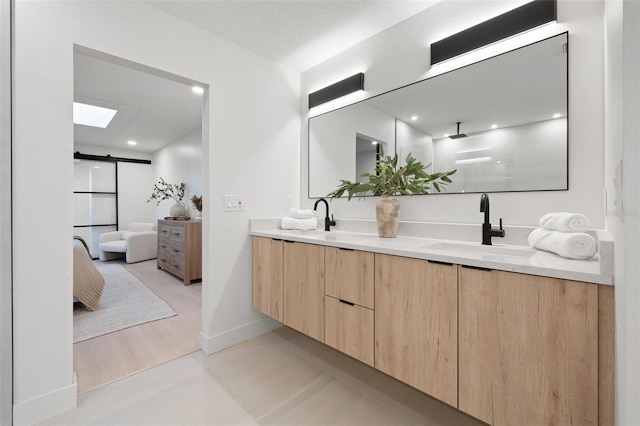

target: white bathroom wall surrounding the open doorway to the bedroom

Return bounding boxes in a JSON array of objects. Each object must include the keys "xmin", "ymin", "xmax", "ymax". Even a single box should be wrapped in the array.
[{"xmin": 12, "ymin": 1, "xmax": 300, "ymax": 425}]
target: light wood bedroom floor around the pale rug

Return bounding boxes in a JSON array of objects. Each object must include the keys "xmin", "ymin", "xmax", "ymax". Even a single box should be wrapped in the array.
[{"xmin": 73, "ymin": 260, "xmax": 202, "ymax": 394}]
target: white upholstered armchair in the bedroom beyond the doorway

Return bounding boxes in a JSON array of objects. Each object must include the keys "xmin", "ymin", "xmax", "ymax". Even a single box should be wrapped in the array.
[{"xmin": 98, "ymin": 223, "xmax": 158, "ymax": 263}]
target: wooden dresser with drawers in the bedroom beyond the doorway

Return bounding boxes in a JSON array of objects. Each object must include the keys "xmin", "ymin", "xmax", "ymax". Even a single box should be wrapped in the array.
[{"xmin": 158, "ymin": 220, "xmax": 202, "ymax": 285}]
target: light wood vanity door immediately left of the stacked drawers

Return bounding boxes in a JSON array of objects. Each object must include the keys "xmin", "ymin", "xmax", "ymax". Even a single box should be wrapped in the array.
[{"xmin": 284, "ymin": 241, "xmax": 324, "ymax": 342}]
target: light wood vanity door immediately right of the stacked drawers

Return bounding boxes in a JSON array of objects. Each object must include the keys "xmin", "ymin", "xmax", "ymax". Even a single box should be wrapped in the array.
[{"xmin": 375, "ymin": 254, "xmax": 458, "ymax": 407}]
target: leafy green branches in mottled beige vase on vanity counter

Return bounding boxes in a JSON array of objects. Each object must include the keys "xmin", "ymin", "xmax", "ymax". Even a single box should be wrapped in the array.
[{"xmin": 327, "ymin": 151, "xmax": 456, "ymax": 238}]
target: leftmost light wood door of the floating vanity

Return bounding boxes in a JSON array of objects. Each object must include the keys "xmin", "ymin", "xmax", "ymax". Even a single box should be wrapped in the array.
[{"xmin": 253, "ymin": 237, "xmax": 284, "ymax": 322}]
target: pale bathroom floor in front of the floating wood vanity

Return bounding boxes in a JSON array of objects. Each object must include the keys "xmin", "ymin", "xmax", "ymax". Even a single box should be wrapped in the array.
[{"xmin": 42, "ymin": 327, "xmax": 482, "ymax": 426}]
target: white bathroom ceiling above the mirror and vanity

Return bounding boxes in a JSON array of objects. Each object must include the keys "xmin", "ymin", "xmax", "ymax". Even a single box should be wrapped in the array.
[{"xmin": 145, "ymin": 0, "xmax": 441, "ymax": 72}]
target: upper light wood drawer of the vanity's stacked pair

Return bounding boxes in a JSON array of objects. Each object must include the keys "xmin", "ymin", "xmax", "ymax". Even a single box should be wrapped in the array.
[{"xmin": 325, "ymin": 247, "xmax": 375, "ymax": 309}]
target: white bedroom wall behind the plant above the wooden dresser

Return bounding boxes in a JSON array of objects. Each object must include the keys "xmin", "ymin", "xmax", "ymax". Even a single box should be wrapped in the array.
[{"xmin": 152, "ymin": 129, "xmax": 202, "ymax": 220}]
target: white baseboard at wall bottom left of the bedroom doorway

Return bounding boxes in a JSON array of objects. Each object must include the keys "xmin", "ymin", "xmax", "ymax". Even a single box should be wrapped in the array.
[{"xmin": 13, "ymin": 373, "xmax": 78, "ymax": 426}]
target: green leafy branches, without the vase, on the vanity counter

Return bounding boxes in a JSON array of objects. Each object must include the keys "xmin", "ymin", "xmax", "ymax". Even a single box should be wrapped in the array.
[{"xmin": 327, "ymin": 147, "xmax": 457, "ymax": 200}]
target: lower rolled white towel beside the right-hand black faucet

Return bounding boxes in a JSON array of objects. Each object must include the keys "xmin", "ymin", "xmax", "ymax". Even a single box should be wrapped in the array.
[{"xmin": 529, "ymin": 228, "xmax": 598, "ymax": 260}]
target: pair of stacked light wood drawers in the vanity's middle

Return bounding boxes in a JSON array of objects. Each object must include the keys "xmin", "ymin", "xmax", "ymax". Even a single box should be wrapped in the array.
[{"xmin": 325, "ymin": 247, "xmax": 374, "ymax": 366}]
